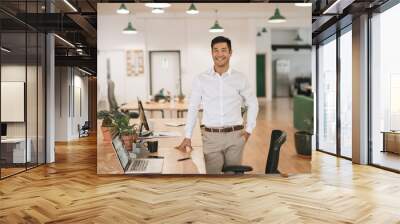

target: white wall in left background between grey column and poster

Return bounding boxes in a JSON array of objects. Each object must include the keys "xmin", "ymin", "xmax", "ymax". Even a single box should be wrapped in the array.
[{"xmin": 55, "ymin": 67, "xmax": 89, "ymax": 141}]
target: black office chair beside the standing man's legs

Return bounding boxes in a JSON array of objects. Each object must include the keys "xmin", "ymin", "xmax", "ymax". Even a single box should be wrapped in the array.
[{"xmin": 222, "ymin": 130, "xmax": 286, "ymax": 174}]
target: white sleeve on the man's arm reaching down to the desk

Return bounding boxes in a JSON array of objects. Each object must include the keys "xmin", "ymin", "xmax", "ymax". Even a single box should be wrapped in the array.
[{"xmin": 185, "ymin": 76, "xmax": 201, "ymax": 138}]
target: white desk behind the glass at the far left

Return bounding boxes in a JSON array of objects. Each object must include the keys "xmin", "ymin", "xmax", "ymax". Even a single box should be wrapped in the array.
[{"xmin": 1, "ymin": 138, "xmax": 32, "ymax": 163}]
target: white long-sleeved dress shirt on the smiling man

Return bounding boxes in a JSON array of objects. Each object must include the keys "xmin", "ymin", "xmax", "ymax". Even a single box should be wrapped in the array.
[{"xmin": 185, "ymin": 68, "xmax": 258, "ymax": 138}]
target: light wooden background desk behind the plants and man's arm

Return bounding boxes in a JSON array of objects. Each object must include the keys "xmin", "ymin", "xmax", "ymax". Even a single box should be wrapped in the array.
[{"xmin": 120, "ymin": 101, "xmax": 188, "ymax": 118}]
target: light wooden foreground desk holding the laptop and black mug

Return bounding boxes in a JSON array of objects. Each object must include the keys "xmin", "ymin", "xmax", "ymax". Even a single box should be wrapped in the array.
[{"xmin": 97, "ymin": 119, "xmax": 206, "ymax": 174}]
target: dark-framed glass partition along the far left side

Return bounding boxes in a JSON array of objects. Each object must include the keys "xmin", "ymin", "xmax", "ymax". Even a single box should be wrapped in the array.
[{"xmin": 0, "ymin": 1, "xmax": 46, "ymax": 178}]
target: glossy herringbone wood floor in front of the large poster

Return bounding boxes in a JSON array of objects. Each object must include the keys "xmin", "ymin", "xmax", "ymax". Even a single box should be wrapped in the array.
[{"xmin": 0, "ymin": 135, "xmax": 400, "ymax": 223}]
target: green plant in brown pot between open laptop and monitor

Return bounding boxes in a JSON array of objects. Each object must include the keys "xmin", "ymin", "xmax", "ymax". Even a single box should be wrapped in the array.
[{"xmin": 114, "ymin": 112, "xmax": 137, "ymax": 150}]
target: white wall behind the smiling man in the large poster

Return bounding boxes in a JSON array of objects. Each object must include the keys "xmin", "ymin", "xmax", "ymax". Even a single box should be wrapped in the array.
[{"xmin": 98, "ymin": 15, "xmax": 256, "ymax": 109}]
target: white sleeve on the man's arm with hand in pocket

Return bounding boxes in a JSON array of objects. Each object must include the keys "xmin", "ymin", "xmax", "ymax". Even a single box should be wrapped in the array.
[{"xmin": 240, "ymin": 79, "xmax": 258, "ymax": 134}]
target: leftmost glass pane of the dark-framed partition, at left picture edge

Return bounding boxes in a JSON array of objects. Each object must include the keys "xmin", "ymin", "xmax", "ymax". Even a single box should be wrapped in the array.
[{"xmin": 0, "ymin": 32, "xmax": 27, "ymax": 177}]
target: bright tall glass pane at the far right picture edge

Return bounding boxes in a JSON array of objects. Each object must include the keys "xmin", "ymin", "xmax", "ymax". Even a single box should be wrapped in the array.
[{"xmin": 370, "ymin": 4, "xmax": 400, "ymax": 171}]
